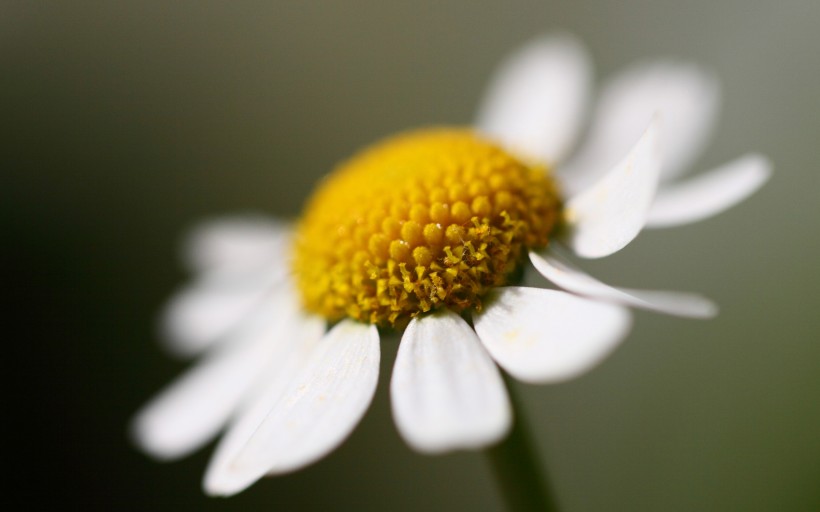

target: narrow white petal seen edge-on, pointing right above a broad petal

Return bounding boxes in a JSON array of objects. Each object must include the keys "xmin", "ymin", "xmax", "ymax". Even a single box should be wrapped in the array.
[{"xmin": 530, "ymin": 251, "xmax": 717, "ymax": 318}]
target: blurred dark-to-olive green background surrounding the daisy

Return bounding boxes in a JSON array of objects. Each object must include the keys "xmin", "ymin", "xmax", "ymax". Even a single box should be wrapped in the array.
[{"xmin": 6, "ymin": 0, "xmax": 820, "ymax": 511}]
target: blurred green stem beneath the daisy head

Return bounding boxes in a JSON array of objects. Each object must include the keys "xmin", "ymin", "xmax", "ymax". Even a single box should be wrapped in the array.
[{"xmin": 485, "ymin": 375, "xmax": 558, "ymax": 512}]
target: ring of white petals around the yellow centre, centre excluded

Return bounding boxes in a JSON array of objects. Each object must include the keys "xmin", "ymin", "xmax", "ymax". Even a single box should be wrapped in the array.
[{"xmin": 134, "ymin": 35, "xmax": 770, "ymax": 495}]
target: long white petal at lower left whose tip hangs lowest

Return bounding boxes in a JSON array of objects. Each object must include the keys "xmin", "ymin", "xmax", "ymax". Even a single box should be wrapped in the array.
[{"xmin": 205, "ymin": 320, "xmax": 379, "ymax": 495}]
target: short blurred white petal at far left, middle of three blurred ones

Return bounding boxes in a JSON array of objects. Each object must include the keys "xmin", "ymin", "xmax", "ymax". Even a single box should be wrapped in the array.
[{"xmin": 161, "ymin": 273, "xmax": 289, "ymax": 357}]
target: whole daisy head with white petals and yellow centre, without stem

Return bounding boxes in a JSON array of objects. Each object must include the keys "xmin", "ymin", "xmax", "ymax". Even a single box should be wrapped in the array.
[{"xmin": 134, "ymin": 35, "xmax": 770, "ymax": 495}]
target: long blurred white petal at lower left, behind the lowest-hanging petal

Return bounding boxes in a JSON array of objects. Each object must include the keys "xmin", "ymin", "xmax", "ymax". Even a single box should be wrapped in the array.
[{"xmin": 134, "ymin": 294, "xmax": 323, "ymax": 459}]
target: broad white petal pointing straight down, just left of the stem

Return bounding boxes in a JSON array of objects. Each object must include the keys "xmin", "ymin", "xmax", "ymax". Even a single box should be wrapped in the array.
[{"xmin": 390, "ymin": 310, "xmax": 511, "ymax": 453}]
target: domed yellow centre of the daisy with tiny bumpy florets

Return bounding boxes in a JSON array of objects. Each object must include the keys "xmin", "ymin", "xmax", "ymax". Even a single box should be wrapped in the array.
[{"xmin": 293, "ymin": 129, "xmax": 560, "ymax": 327}]
